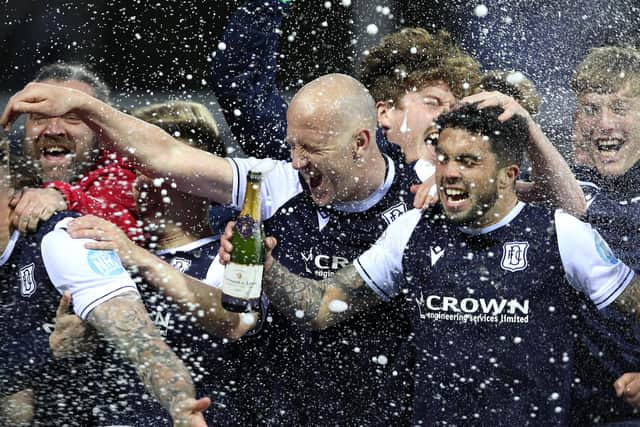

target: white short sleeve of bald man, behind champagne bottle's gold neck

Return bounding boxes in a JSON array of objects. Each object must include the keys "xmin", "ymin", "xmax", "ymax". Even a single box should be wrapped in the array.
[{"xmin": 227, "ymin": 157, "xmax": 302, "ymax": 221}]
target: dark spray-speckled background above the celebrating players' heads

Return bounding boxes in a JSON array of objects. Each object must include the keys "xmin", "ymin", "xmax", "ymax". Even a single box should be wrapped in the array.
[{"xmin": 0, "ymin": 0, "xmax": 640, "ymax": 153}]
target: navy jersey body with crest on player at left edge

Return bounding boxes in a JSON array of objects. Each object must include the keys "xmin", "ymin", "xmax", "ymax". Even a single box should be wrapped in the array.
[{"xmin": 0, "ymin": 212, "xmax": 101, "ymax": 425}]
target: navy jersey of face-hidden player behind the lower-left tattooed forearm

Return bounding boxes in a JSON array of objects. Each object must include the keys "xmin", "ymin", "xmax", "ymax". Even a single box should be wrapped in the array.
[{"xmin": 96, "ymin": 236, "xmax": 251, "ymax": 427}]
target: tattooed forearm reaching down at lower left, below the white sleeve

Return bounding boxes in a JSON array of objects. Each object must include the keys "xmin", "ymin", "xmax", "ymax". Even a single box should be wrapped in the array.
[{"xmin": 87, "ymin": 293, "xmax": 195, "ymax": 414}]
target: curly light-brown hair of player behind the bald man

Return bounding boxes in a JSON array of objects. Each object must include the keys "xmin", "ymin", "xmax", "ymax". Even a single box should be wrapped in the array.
[{"xmin": 360, "ymin": 28, "xmax": 480, "ymax": 104}]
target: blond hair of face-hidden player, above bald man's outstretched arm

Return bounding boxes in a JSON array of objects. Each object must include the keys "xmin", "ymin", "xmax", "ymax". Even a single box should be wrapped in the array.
[{"xmin": 131, "ymin": 101, "xmax": 226, "ymax": 157}]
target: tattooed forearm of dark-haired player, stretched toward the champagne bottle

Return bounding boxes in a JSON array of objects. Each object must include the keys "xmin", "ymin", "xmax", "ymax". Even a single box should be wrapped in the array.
[{"xmin": 263, "ymin": 260, "xmax": 382, "ymax": 329}]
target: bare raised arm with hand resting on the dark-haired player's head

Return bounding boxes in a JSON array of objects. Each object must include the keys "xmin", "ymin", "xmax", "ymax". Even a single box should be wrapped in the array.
[{"xmin": 463, "ymin": 92, "xmax": 587, "ymax": 217}]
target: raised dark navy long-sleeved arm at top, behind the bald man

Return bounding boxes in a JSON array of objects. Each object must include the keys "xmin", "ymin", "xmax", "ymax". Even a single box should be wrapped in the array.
[{"xmin": 213, "ymin": 0, "xmax": 290, "ymax": 160}]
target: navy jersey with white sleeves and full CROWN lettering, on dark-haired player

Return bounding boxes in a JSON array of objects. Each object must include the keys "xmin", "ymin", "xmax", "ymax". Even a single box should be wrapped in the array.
[{"xmin": 356, "ymin": 203, "xmax": 634, "ymax": 426}]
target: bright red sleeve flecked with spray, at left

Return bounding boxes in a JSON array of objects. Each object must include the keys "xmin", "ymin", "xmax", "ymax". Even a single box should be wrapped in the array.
[{"xmin": 45, "ymin": 164, "xmax": 144, "ymax": 243}]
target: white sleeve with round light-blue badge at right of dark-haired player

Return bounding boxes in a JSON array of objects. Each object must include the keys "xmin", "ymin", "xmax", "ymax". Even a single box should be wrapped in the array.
[{"xmin": 555, "ymin": 211, "xmax": 634, "ymax": 309}]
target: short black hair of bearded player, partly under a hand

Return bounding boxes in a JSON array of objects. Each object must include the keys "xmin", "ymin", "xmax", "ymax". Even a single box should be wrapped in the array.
[{"xmin": 434, "ymin": 104, "xmax": 529, "ymax": 166}]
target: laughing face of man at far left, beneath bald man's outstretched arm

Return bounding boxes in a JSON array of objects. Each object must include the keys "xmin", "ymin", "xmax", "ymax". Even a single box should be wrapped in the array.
[{"xmin": 24, "ymin": 80, "xmax": 98, "ymax": 182}]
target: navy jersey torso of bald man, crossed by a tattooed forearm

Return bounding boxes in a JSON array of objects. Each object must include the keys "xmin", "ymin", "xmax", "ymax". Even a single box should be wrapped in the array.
[{"xmin": 232, "ymin": 159, "xmax": 416, "ymax": 425}]
